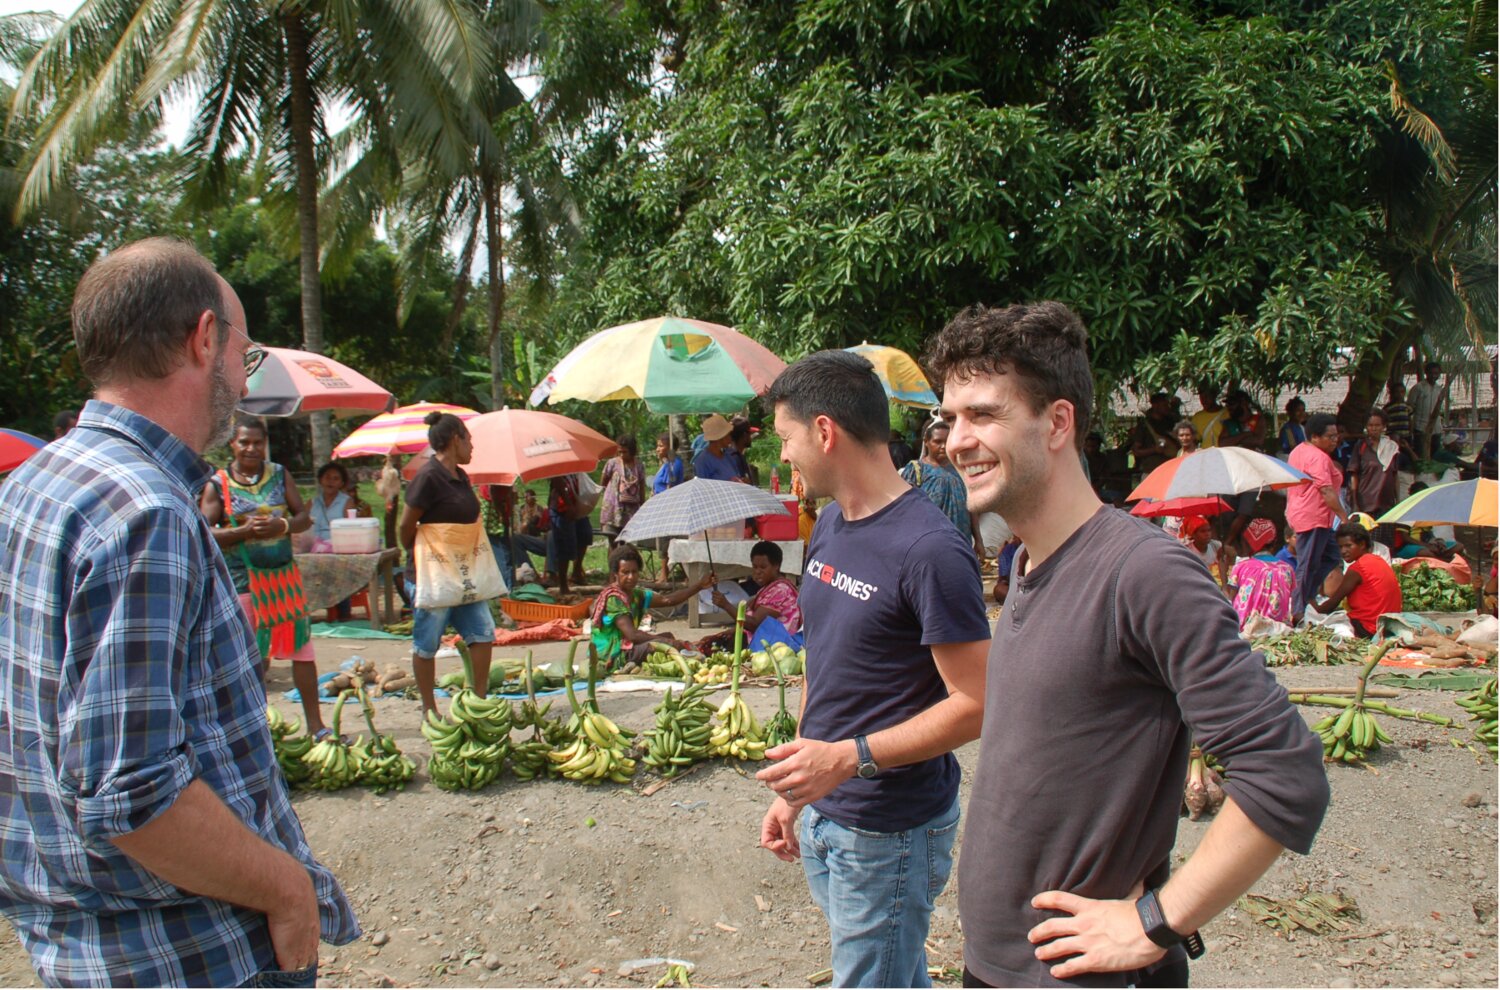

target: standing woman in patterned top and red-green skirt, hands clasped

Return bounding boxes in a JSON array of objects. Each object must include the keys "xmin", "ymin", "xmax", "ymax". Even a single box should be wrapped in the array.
[{"xmin": 200, "ymin": 417, "xmax": 327, "ymax": 738}]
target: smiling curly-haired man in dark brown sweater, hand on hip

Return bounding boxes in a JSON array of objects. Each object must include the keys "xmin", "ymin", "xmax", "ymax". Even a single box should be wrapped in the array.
[{"xmin": 927, "ymin": 303, "xmax": 1329, "ymax": 987}]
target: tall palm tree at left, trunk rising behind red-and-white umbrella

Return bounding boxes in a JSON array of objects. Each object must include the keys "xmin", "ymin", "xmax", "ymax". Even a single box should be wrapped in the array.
[{"xmin": 11, "ymin": 0, "xmax": 491, "ymax": 462}]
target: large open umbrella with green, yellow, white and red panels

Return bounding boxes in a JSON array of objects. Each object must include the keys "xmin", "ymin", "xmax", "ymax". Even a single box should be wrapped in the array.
[{"xmin": 531, "ymin": 317, "xmax": 786, "ymax": 413}]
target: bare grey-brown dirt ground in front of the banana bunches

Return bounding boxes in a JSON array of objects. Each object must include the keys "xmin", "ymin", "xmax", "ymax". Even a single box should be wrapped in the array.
[{"xmin": 0, "ymin": 623, "xmax": 1497, "ymax": 987}]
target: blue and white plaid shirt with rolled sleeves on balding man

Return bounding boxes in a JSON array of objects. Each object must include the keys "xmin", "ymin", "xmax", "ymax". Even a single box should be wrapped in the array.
[{"xmin": 0, "ymin": 402, "xmax": 360, "ymax": 987}]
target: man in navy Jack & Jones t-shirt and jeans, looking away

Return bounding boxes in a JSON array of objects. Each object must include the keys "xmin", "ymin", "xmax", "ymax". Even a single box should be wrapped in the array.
[{"xmin": 758, "ymin": 351, "xmax": 990, "ymax": 987}]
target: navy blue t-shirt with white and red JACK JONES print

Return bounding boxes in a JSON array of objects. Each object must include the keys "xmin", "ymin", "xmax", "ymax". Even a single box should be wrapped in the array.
[{"xmin": 798, "ymin": 489, "xmax": 990, "ymax": 833}]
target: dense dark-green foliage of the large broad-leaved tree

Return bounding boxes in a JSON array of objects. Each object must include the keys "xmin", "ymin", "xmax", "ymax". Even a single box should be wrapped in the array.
[{"xmin": 540, "ymin": 0, "xmax": 1494, "ymax": 411}]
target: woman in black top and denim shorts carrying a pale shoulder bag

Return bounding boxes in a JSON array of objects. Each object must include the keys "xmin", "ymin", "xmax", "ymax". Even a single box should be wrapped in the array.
[{"xmin": 401, "ymin": 413, "xmax": 506, "ymax": 713}]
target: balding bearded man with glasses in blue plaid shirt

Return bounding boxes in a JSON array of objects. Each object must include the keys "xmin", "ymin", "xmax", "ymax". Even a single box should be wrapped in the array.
[{"xmin": 0, "ymin": 240, "xmax": 360, "ymax": 987}]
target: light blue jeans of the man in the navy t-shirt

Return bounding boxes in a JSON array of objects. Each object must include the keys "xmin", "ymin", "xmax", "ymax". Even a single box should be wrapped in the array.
[{"xmin": 801, "ymin": 801, "xmax": 959, "ymax": 987}]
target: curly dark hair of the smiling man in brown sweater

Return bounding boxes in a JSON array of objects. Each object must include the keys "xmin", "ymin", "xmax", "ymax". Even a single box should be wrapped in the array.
[{"xmin": 923, "ymin": 300, "xmax": 1094, "ymax": 450}]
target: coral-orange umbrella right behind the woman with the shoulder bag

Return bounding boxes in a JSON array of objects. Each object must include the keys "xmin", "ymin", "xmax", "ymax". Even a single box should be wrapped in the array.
[{"xmin": 404, "ymin": 410, "xmax": 620, "ymax": 485}]
